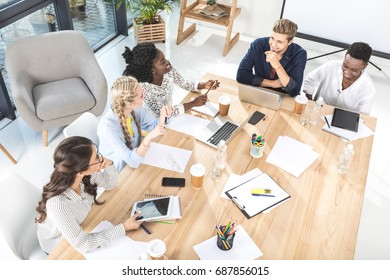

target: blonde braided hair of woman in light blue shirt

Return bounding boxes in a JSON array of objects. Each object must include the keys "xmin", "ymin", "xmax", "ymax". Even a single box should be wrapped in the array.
[{"xmin": 111, "ymin": 76, "xmax": 141, "ymax": 150}]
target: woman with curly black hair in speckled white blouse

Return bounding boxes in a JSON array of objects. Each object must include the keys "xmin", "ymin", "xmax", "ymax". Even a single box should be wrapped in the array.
[{"xmin": 122, "ymin": 43, "xmax": 219, "ymax": 117}]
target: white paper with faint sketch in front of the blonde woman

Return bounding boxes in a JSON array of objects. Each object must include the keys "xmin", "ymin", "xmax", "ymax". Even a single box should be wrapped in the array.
[{"xmin": 142, "ymin": 142, "xmax": 192, "ymax": 173}]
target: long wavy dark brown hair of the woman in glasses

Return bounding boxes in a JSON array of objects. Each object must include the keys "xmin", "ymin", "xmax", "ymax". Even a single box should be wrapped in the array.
[{"xmin": 35, "ymin": 136, "xmax": 103, "ymax": 223}]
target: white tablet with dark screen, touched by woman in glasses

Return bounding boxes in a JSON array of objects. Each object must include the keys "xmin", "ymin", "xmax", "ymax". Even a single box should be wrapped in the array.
[{"xmin": 131, "ymin": 196, "xmax": 173, "ymax": 221}]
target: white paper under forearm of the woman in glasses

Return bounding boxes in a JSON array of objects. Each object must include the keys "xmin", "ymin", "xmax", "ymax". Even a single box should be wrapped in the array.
[{"xmin": 84, "ymin": 221, "xmax": 148, "ymax": 260}]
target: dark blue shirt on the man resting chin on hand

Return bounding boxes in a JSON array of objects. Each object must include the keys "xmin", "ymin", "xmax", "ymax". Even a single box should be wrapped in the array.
[{"xmin": 236, "ymin": 37, "xmax": 307, "ymax": 96}]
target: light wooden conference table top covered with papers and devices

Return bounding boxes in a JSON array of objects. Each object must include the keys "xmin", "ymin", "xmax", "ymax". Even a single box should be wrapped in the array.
[{"xmin": 48, "ymin": 74, "xmax": 376, "ymax": 260}]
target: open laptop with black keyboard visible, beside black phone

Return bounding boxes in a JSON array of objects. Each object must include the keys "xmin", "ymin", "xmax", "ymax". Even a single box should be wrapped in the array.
[{"xmin": 195, "ymin": 116, "xmax": 250, "ymax": 148}]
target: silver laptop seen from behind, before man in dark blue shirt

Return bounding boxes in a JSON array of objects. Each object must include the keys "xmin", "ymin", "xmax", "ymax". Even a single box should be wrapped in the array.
[{"xmin": 238, "ymin": 83, "xmax": 284, "ymax": 110}]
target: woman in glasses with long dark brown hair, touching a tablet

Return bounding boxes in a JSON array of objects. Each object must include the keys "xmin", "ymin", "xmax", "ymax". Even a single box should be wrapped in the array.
[{"xmin": 35, "ymin": 136, "xmax": 141, "ymax": 253}]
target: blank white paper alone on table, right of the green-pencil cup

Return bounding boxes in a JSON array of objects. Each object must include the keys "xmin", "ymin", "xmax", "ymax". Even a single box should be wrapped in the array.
[{"xmin": 266, "ymin": 136, "xmax": 319, "ymax": 177}]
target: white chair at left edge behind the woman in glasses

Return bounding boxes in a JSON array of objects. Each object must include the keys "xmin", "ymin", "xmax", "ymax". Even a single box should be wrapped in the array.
[{"xmin": 0, "ymin": 172, "xmax": 47, "ymax": 260}]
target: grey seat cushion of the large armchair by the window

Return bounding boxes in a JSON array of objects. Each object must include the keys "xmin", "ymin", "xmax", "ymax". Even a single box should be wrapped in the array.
[{"xmin": 33, "ymin": 78, "xmax": 96, "ymax": 121}]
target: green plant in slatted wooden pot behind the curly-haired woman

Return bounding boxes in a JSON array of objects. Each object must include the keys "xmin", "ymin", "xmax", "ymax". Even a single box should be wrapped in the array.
[{"xmin": 115, "ymin": 0, "xmax": 180, "ymax": 43}]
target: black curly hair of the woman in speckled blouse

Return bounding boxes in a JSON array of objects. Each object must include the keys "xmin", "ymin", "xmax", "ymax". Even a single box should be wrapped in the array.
[{"xmin": 122, "ymin": 43, "xmax": 159, "ymax": 83}]
